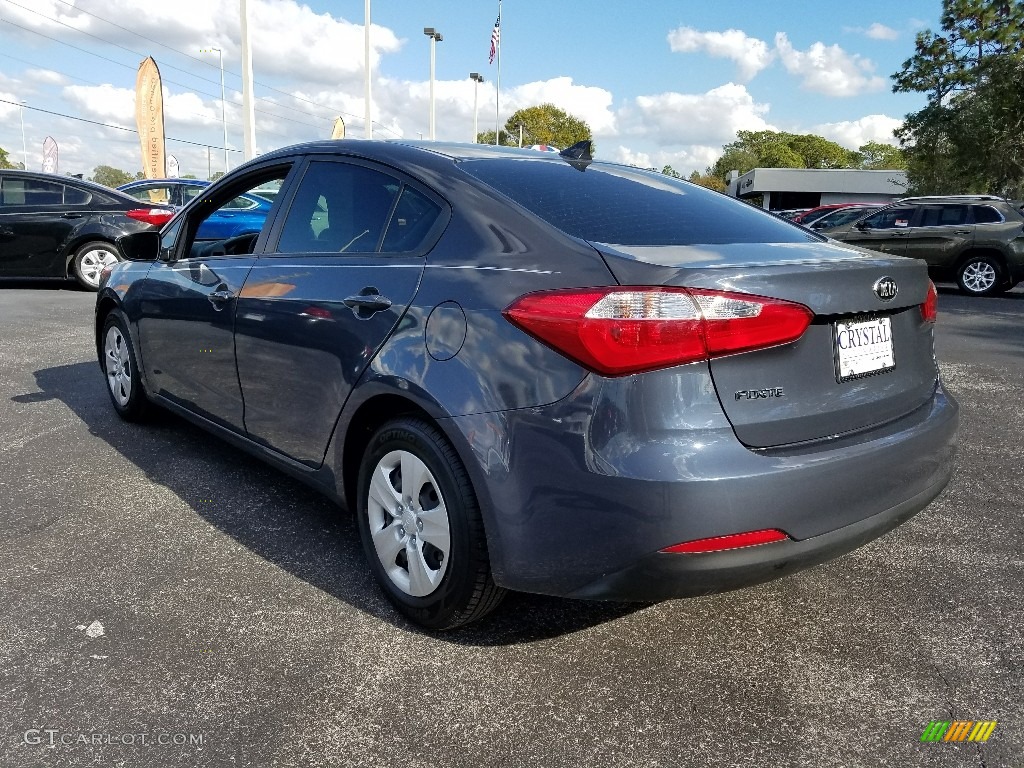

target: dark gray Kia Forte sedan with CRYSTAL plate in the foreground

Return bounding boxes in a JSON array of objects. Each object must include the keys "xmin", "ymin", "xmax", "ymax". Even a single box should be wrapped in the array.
[{"xmin": 95, "ymin": 140, "xmax": 957, "ymax": 629}]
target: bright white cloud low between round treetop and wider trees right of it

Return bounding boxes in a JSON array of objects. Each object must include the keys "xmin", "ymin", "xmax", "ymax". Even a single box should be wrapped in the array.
[{"xmin": 620, "ymin": 83, "xmax": 771, "ymax": 147}]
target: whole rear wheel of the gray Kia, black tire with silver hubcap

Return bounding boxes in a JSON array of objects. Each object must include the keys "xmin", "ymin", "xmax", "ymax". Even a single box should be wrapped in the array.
[{"xmin": 355, "ymin": 418, "xmax": 505, "ymax": 630}]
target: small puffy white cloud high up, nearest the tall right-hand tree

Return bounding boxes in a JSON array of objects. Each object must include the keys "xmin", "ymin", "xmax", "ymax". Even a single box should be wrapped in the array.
[{"xmin": 775, "ymin": 32, "xmax": 886, "ymax": 96}]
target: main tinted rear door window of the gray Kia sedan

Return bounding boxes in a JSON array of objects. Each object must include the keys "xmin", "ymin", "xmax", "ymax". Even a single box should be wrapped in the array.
[{"xmin": 278, "ymin": 162, "xmax": 401, "ymax": 253}]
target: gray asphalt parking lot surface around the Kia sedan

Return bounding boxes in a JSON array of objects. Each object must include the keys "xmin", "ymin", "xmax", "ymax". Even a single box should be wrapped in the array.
[{"xmin": 0, "ymin": 282, "xmax": 1024, "ymax": 768}]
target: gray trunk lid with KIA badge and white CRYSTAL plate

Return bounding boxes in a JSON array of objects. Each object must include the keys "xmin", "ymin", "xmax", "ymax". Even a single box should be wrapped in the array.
[{"xmin": 595, "ymin": 243, "xmax": 938, "ymax": 447}]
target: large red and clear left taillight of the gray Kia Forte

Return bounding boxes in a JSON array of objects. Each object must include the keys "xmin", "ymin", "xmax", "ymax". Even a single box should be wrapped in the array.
[{"xmin": 504, "ymin": 287, "xmax": 813, "ymax": 376}]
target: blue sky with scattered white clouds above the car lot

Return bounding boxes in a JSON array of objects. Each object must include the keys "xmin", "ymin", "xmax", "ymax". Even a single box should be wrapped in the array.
[{"xmin": 0, "ymin": 0, "xmax": 941, "ymax": 178}]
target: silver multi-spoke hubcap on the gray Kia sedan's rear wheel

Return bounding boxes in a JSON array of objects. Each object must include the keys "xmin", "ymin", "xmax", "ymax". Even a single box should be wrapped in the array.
[{"xmin": 367, "ymin": 451, "xmax": 452, "ymax": 597}]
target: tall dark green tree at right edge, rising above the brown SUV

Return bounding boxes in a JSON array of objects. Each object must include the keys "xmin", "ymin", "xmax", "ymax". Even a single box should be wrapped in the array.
[{"xmin": 893, "ymin": 0, "xmax": 1024, "ymax": 197}]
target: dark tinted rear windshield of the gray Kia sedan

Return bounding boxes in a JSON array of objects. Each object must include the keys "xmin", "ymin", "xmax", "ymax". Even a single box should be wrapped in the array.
[{"xmin": 461, "ymin": 158, "xmax": 820, "ymax": 246}]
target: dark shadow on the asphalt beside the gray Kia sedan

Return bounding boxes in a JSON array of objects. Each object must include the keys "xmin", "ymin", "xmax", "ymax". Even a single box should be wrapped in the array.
[{"xmin": 19, "ymin": 362, "xmax": 644, "ymax": 646}]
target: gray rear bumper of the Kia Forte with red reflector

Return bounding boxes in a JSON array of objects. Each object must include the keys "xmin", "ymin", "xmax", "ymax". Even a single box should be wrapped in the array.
[{"xmin": 444, "ymin": 366, "xmax": 958, "ymax": 600}]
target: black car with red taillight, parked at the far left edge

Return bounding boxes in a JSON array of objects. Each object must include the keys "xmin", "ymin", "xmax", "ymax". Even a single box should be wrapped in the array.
[{"xmin": 0, "ymin": 170, "xmax": 173, "ymax": 291}]
